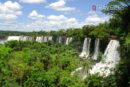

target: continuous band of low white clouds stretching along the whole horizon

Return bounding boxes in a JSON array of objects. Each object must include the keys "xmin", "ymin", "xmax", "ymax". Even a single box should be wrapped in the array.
[{"xmin": 0, "ymin": 10, "xmax": 108, "ymax": 31}]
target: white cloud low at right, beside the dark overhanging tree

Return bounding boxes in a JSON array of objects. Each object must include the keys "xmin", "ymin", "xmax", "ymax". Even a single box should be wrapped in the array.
[{"xmin": 85, "ymin": 12, "xmax": 109, "ymax": 25}]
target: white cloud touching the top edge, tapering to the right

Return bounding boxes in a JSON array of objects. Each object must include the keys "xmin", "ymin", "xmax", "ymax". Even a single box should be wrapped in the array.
[{"xmin": 46, "ymin": 0, "xmax": 76, "ymax": 12}]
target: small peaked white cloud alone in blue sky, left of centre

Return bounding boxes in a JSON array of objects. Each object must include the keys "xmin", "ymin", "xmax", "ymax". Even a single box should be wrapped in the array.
[{"xmin": 28, "ymin": 10, "xmax": 45, "ymax": 20}]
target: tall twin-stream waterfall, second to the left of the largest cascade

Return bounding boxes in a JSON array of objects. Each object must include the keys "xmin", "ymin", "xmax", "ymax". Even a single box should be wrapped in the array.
[{"xmin": 79, "ymin": 38, "xmax": 91, "ymax": 58}]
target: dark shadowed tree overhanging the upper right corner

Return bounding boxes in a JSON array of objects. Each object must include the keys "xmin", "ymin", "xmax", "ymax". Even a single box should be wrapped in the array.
[{"xmin": 103, "ymin": 0, "xmax": 130, "ymax": 35}]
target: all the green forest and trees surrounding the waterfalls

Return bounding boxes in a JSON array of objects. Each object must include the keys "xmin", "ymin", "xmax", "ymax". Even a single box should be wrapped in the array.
[{"xmin": 0, "ymin": 0, "xmax": 130, "ymax": 87}]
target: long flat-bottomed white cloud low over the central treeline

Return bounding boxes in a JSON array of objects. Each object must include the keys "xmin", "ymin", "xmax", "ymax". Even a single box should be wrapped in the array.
[{"xmin": 24, "ymin": 14, "xmax": 81, "ymax": 31}]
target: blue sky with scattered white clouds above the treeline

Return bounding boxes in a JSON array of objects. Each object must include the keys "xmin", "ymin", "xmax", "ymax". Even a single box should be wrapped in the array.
[{"xmin": 0, "ymin": 0, "xmax": 110, "ymax": 31}]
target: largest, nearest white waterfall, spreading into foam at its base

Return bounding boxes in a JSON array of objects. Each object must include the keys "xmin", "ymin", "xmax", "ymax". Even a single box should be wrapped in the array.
[{"xmin": 90, "ymin": 40, "xmax": 120, "ymax": 76}]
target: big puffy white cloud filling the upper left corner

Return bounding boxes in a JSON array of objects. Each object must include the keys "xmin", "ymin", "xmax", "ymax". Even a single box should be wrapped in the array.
[{"xmin": 0, "ymin": 1, "xmax": 22, "ymax": 22}]
